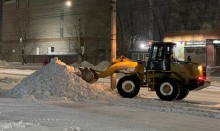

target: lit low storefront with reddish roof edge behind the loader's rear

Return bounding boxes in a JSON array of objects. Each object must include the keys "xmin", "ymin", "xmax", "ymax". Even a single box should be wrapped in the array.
[{"xmin": 164, "ymin": 28, "xmax": 220, "ymax": 67}]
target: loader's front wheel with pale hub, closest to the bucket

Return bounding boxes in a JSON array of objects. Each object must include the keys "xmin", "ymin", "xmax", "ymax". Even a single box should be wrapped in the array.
[{"xmin": 117, "ymin": 76, "xmax": 140, "ymax": 98}]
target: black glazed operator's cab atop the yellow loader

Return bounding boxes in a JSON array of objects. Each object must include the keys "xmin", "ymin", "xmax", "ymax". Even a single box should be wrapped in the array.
[{"xmin": 147, "ymin": 42, "xmax": 175, "ymax": 70}]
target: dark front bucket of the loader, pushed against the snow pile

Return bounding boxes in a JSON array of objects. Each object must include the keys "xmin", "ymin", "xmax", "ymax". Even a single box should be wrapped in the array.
[{"xmin": 79, "ymin": 67, "xmax": 99, "ymax": 84}]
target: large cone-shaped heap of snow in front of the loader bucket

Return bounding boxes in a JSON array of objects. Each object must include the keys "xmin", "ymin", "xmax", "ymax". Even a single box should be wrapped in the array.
[{"xmin": 5, "ymin": 58, "xmax": 115, "ymax": 102}]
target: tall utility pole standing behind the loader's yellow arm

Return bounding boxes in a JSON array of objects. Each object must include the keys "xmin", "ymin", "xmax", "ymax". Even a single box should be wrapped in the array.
[{"xmin": 111, "ymin": 0, "xmax": 116, "ymax": 89}]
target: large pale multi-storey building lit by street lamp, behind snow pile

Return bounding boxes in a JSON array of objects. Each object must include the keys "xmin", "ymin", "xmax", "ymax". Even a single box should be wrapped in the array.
[{"xmin": 2, "ymin": 0, "xmax": 111, "ymax": 62}]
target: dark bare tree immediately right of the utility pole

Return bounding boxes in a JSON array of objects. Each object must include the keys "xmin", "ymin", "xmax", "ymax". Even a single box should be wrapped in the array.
[{"xmin": 117, "ymin": 0, "xmax": 139, "ymax": 54}]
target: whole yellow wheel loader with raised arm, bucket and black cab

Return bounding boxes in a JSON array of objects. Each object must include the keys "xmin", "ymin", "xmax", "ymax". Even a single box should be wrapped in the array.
[{"xmin": 78, "ymin": 42, "xmax": 210, "ymax": 101}]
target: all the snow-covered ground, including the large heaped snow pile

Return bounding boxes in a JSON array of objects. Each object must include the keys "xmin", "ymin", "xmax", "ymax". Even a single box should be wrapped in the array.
[{"xmin": 0, "ymin": 61, "xmax": 220, "ymax": 131}]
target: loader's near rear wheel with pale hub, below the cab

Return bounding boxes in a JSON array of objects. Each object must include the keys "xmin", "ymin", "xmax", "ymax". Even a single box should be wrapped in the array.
[{"xmin": 156, "ymin": 80, "xmax": 181, "ymax": 101}]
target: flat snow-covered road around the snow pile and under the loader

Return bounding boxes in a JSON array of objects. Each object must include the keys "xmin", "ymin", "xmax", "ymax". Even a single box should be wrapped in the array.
[{"xmin": 0, "ymin": 69, "xmax": 220, "ymax": 131}]
